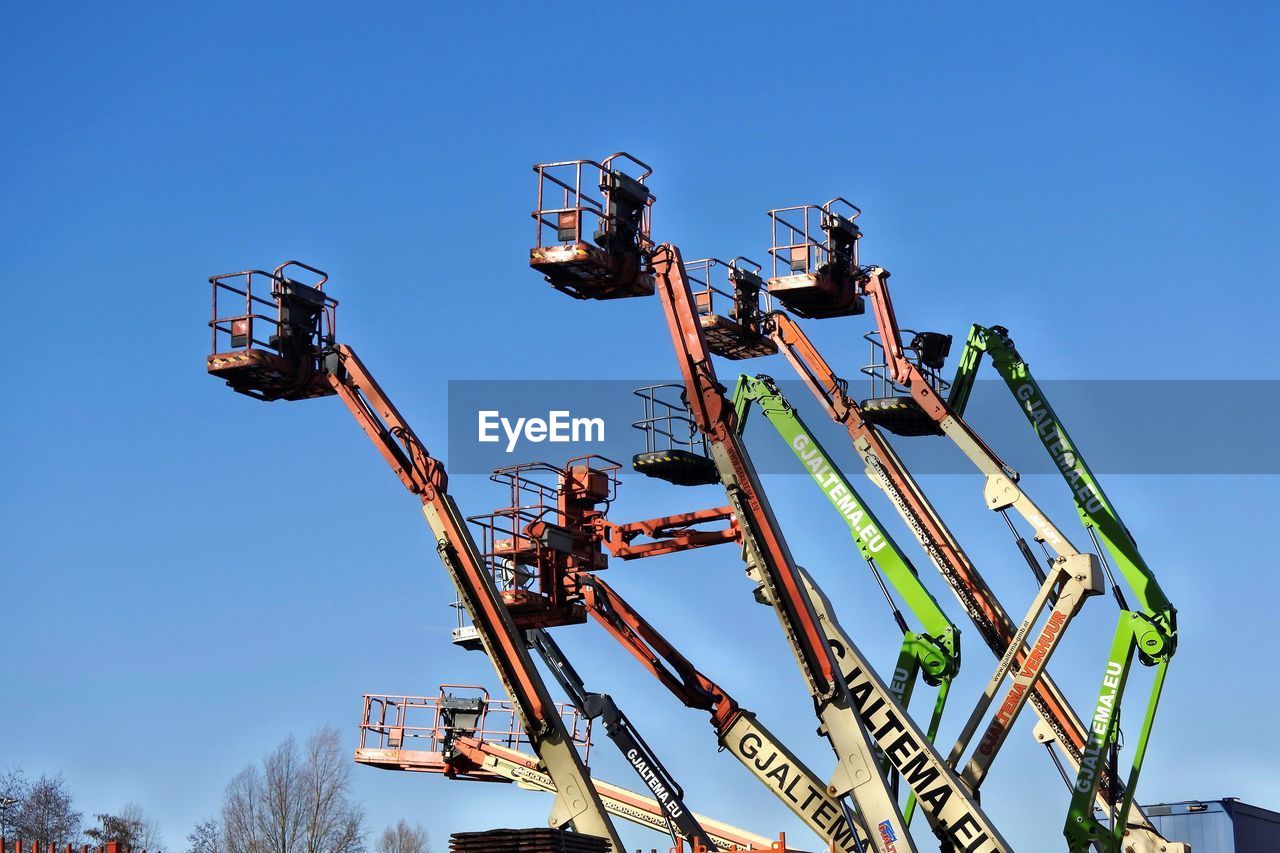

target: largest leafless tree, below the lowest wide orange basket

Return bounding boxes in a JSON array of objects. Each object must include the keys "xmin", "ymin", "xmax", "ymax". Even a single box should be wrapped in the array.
[{"xmin": 221, "ymin": 727, "xmax": 365, "ymax": 853}]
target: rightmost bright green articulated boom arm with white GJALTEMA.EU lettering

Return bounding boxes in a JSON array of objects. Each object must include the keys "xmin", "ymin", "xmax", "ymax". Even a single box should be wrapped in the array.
[{"xmin": 947, "ymin": 325, "xmax": 1178, "ymax": 849}]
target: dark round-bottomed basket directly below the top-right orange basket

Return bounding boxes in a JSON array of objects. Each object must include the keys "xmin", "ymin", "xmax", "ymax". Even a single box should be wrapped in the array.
[{"xmin": 861, "ymin": 329, "xmax": 951, "ymax": 435}]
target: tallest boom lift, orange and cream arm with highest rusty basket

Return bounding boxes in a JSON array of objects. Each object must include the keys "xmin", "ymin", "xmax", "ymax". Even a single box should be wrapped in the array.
[{"xmin": 529, "ymin": 152, "xmax": 914, "ymax": 853}]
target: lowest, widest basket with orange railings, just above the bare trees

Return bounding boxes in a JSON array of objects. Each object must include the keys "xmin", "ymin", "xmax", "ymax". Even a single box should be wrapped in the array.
[{"xmin": 356, "ymin": 684, "xmax": 591, "ymax": 781}]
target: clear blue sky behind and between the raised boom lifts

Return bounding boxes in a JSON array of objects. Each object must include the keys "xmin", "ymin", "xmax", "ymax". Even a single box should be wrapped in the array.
[{"xmin": 0, "ymin": 3, "xmax": 1280, "ymax": 849}]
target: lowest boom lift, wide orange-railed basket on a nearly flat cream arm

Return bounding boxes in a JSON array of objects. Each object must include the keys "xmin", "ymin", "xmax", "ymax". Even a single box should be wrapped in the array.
[{"xmin": 356, "ymin": 684, "xmax": 771, "ymax": 850}]
